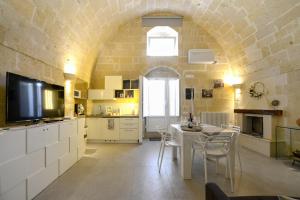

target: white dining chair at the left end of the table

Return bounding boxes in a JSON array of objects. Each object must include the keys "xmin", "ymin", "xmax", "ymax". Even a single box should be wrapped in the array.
[{"xmin": 157, "ymin": 132, "xmax": 181, "ymax": 173}]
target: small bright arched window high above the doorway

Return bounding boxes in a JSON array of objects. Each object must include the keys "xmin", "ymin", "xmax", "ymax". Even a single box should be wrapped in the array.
[{"xmin": 147, "ymin": 26, "xmax": 178, "ymax": 56}]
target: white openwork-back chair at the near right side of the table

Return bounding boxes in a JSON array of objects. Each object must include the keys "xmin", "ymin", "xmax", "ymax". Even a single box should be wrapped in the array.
[{"xmin": 192, "ymin": 133, "xmax": 234, "ymax": 192}]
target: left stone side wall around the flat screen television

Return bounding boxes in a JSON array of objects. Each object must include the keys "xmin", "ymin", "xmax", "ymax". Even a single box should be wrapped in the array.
[{"xmin": 0, "ymin": 44, "xmax": 74, "ymax": 127}]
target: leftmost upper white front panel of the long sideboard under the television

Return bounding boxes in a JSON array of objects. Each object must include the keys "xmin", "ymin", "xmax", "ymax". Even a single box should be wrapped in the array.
[{"xmin": 0, "ymin": 130, "xmax": 26, "ymax": 164}]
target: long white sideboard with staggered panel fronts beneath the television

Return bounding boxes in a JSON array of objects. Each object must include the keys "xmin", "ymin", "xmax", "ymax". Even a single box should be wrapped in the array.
[{"xmin": 0, "ymin": 119, "xmax": 84, "ymax": 200}]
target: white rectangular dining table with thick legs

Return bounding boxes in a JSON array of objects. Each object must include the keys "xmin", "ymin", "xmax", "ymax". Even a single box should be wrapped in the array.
[{"xmin": 170, "ymin": 124, "xmax": 236, "ymax": 179}]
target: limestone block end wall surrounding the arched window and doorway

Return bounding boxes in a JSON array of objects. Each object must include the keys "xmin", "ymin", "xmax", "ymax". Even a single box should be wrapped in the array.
[{"xmin": 91, "ymin": 17, "xmax": 234, "ymax": 117}]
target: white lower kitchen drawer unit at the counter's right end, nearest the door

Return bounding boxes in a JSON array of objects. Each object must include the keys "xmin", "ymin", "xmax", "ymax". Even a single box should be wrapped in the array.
[{"xmin": 120, "ymin": 118, "xmax": 139, "ymax": 140}]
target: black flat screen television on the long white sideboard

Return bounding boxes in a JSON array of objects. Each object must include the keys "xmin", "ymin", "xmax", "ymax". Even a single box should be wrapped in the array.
[{"xmin": 6, "ymin": 72, "xmax": 65, "ymax": 123}]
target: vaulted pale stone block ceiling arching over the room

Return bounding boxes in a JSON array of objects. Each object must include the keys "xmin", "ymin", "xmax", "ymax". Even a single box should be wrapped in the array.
[{"xmin": 0, "ymin": 0, "xmax": 300, "ymax": 80}]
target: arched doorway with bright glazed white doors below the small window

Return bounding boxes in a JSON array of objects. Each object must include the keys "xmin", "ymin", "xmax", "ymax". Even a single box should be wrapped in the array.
[{"xmin": 143, "ymin": 67, "xmax": 180, "ymax": 140}]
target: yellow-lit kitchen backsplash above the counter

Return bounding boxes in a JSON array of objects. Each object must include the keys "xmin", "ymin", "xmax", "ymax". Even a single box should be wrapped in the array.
[{"xmin": 92, "ymin": 103, "xmax": 139, "ymax": 115}]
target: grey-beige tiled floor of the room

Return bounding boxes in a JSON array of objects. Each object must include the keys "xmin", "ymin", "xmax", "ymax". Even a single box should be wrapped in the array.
[{"xmin": 36, "ymin": 141, "xmax": 300, "ymax": 200}]
